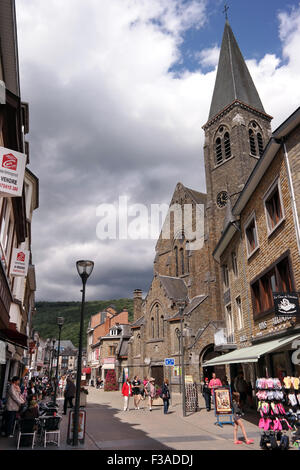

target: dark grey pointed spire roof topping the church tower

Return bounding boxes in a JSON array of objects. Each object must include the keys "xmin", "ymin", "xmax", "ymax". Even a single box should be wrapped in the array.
[{"xmin": 209, "ymin": 19, "xmax": 265, "ymax": 120}]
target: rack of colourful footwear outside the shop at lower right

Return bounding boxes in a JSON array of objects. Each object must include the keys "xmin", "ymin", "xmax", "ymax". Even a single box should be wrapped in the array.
[{"xmin": 256, "ymin": 377, "xmax": 300, "ymax": 450}]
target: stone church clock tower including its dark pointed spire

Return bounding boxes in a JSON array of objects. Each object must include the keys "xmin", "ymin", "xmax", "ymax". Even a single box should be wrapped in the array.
[{"xmin": 203, "ymin": 20, "xmax": 272, "ymax": 242}]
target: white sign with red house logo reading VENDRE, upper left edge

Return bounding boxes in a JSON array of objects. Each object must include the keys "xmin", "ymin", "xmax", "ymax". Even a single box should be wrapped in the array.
[{"xmin": 0, "ymin": 147, "xmax": 26, "ymax": 197}]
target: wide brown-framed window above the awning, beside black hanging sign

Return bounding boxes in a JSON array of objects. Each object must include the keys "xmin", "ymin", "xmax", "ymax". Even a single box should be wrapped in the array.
[{"xmin": 251, "ymin": 257, "xmax": 293, "ymax": 316}]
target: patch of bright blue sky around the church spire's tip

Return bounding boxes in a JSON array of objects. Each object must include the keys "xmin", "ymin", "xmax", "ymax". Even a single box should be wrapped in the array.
[{"xmin": 171, "ymin": 0, "xmax": 299, "ymax": 71}]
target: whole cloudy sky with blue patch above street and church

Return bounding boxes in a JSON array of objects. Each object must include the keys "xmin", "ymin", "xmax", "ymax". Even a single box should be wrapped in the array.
[{"xmin": 16, "ymin": 0, "xmax": 300, "ymax": 300}]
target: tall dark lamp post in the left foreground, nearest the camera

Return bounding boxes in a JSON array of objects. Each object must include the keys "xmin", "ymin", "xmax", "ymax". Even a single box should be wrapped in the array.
[{"xmin": 73, "ymin": 260, "xmax": 94, "ymax": 446}]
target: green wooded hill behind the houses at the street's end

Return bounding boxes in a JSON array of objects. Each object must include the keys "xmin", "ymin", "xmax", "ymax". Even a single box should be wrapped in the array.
[{"xmin": 32, "ymin": 299, "xmax": 133, "ymax": 347}]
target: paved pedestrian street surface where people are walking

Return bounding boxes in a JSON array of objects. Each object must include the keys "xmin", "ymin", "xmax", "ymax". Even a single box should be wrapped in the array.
[{"xmin": 0, "ymin": 387, "xmax": 260, "ymax": 450}]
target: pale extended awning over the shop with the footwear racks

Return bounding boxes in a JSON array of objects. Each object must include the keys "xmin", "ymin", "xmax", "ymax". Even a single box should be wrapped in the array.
[{"xmin": 202, "ymin": 333, "xmax": 300, "ymax": 367}]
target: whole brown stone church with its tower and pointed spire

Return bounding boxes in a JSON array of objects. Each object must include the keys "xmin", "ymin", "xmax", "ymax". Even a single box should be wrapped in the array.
[{"xmin": 128, "ymin": 20, "xmax": 300, "ymax": 391}]
